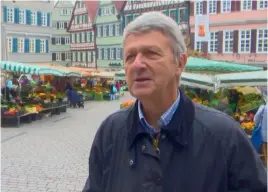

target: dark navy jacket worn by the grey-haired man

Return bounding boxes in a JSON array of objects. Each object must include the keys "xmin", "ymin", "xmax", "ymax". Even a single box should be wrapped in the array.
[{"xmin": 83, "ymin": 93, "xmax": 267, "ymax": 192}]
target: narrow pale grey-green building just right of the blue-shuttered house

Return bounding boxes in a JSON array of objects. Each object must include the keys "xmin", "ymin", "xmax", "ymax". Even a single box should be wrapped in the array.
[{"xmin": 50, "ymin": 0, "xmax": 74, "ymax": 66}]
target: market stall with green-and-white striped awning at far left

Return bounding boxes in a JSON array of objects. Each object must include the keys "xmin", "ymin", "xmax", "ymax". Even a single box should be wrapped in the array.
[{"xmin": 0, "ymin": 61, "xmax": 71, "ymax": 127}]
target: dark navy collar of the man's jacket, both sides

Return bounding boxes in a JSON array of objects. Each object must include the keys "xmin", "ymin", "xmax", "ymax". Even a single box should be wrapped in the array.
[{"xmin": 127, "ymin": 91, "xmax": 195, "ymax": 148}]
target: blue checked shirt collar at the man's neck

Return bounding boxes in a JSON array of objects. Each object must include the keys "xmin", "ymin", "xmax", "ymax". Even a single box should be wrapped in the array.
[{"xmin": 138, "ymin": 91, "xmax": 180, "ymax": 134}]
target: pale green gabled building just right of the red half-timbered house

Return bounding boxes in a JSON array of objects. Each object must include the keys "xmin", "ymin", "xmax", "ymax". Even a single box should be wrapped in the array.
[{"xmin": 95, "ymin": 0, "xmax": 125, "ymax": 71}]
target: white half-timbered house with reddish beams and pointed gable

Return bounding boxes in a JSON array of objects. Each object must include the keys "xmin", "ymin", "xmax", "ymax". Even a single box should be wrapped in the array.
[{"xmin": 67, "ymin": 1, "xmax": 98, "ymax": 68}]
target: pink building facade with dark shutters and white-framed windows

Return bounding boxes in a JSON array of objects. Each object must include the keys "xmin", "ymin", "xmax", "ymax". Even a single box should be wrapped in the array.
[{"xmin": 190, "ymin": 0, "xmax": 268, "ymax": 66}]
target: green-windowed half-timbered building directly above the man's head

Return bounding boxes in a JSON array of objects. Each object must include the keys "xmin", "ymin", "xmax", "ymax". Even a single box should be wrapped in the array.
[{"xmin": 122, "ymin": 0, "xmax": 189, "ymax": 35}]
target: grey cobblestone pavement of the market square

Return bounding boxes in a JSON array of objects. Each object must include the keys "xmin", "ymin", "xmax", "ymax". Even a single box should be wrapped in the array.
[{"xmin": 1, "ymin": 93, "xmax": 133, "ymax": 192}]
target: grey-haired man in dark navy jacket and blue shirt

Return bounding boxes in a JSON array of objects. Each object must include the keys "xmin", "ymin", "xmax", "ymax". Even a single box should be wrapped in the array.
[{"xmin": 84, "ymin": 12, "xmax": 267, "ymax": 192}]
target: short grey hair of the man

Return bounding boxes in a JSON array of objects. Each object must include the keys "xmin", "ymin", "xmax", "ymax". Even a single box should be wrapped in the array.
[{"xmin": 123, "ymin": 11, "xmax": 187, "ymax": 60}]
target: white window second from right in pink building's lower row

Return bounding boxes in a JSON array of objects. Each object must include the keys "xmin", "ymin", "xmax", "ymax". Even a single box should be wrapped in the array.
[{"xmin": 239, "ymin": 30, "xmax": 251, "ymax": 53}]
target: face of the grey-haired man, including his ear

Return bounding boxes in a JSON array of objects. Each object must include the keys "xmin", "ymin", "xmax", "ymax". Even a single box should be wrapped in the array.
[{"xmin": 124, "ymin": 31, "xmax": 181, "ymax": 99}]
